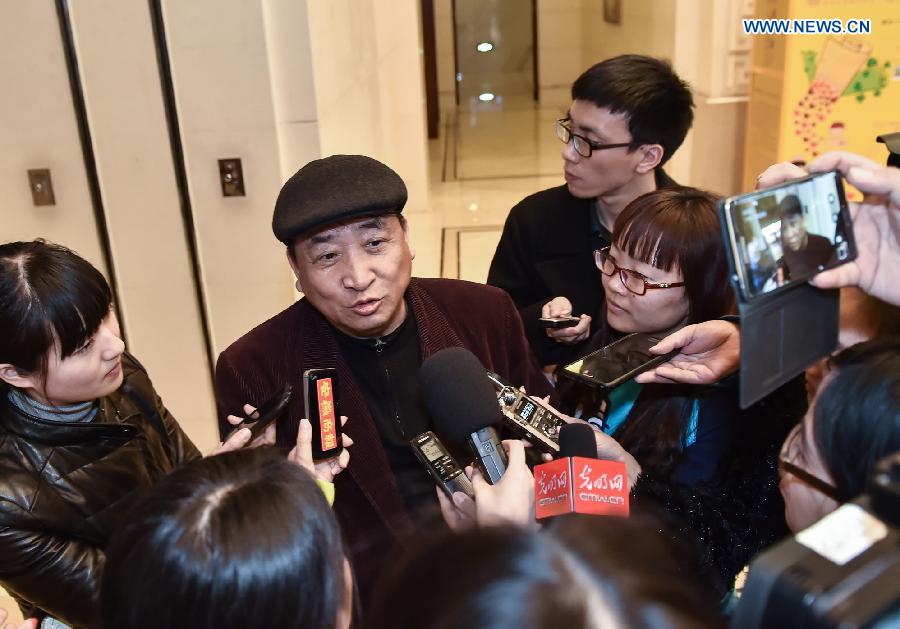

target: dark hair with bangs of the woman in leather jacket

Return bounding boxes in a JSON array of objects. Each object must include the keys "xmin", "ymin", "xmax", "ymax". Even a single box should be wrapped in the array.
[{"xmin": 0, "ymin": 240, "xmax": 112, "ymax": 378}]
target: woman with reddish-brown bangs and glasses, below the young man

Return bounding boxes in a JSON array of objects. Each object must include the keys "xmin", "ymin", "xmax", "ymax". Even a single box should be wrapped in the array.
[{"xmin": 551, "ymin": 188, "xmax": 738, "ymax": 485}]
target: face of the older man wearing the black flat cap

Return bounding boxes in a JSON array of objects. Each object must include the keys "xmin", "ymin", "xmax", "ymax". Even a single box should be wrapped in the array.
[{"xmin": 288, "ymin": 215, "xmax": 414, "ymax": 338}]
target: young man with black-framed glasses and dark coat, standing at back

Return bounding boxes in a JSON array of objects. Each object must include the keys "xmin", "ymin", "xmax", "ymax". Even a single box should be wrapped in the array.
[{"xmin": 487, "ymin": 55, "xmax": 694, "ymax": 364}]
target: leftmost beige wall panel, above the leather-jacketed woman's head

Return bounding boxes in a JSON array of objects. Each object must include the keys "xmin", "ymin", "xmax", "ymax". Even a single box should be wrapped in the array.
[{"xmin": 0, "ymin": 1, "xmax": 108, "ymax": 277}]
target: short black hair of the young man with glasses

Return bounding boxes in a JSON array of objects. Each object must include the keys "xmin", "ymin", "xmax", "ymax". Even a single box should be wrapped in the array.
[{"xmin": 572, "ymin": 55, "xmax": 694, "ymax": 165}]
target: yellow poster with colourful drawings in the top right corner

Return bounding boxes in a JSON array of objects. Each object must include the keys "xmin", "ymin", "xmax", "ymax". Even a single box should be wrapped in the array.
[{"xmin": 745, "ymin": 0, "xmax": 900, "ymax": 190}]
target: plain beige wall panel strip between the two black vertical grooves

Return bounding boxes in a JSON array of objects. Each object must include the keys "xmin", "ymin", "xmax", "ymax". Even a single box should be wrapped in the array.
[{"xmin": 71, "ymin": 0, "xmax": 216, "ymax": 448}]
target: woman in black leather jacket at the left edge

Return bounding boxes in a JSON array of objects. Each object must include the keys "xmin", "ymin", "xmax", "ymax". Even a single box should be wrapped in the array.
[{"xmin": 0, "ymin": 241, "xmax": 200, "ymax": 626}]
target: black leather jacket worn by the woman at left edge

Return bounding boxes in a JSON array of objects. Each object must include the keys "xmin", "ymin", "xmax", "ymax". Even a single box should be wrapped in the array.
[{"xmin": 0, "ymin": 354, "xmax": 200, "ymax": 626}]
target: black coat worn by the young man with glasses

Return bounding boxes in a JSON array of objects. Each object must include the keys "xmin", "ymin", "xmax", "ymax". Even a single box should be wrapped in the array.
[{"xmin": 487, "ymin": 168, "xmax": 678, "ymax": 365}]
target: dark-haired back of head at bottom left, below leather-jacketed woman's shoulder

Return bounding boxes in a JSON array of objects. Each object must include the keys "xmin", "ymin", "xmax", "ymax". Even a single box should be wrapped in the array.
[{"xmin": 98, "ymin": 448, "xmax": 344, "ymax": 629}]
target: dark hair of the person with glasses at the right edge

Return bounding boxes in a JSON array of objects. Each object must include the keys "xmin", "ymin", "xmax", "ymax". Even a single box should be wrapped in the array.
[{"xmin": 813, "ymin": 337, "xmax": 900, "ymax": 500}]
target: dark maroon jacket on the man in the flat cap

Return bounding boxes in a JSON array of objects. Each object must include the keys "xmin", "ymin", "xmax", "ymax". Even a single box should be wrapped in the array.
[{"xmin": 216, "ymin": 278, "xmax": 551, "ymax": 601}]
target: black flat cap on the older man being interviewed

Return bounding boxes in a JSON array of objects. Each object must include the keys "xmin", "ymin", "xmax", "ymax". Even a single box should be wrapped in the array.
[{"xmin": 272, "ymin": 155, "xmax": 407, "ymax": 245}]
